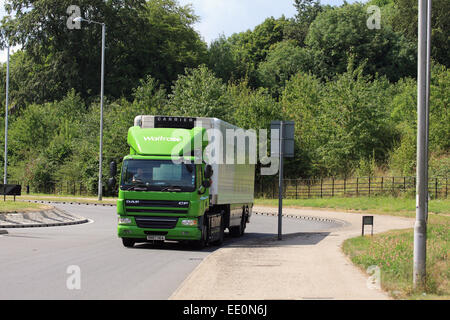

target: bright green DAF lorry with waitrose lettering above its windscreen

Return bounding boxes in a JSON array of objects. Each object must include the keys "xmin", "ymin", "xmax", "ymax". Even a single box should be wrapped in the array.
[{"xmin": 117, "ymin": 116, "xmax": 255, "ymax": 248}]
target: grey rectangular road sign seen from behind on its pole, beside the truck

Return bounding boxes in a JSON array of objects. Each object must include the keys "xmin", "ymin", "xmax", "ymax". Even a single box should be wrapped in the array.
[{"xmin": 270, "ymin": 121, "xmax": 295, "ymax": 240}]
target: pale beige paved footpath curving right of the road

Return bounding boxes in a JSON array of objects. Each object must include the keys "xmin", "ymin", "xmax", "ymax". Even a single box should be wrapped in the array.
[{"xmin": 170, "ymin": 206, "xmax": 414, "ymax": 300}]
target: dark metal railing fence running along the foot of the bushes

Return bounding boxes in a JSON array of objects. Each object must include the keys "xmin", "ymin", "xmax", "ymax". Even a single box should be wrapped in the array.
[{"xmin": 7, "ymin": 176, "xmax": 449, "ymax": 199}]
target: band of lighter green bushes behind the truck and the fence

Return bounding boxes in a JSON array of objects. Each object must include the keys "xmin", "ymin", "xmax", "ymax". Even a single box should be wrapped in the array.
[{"xmin": 1, "ymin": 62, "xmax": 450, "ymax": 190}]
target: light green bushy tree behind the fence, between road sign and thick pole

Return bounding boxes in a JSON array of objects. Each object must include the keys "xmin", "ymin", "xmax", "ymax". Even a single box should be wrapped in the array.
[{"xmin": 318, "ymin": 66, "xmax": 394, "ymax": 174}]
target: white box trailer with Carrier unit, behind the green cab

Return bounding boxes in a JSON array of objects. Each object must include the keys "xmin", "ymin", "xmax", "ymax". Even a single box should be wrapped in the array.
[{"xmin": 134, "ymin": 115, "xmax": 256, "ymax": 205}]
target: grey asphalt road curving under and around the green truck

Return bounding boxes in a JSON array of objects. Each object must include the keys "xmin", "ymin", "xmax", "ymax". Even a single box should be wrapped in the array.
[{"xmin": 0, "ymin": 205, "xmax": 336, "ymax": 300}]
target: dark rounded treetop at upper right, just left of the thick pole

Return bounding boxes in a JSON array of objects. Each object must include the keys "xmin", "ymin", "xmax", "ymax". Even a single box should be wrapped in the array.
[{"xmin": 306, "ymin": 3, "xmax": 416, "ymax": 81}]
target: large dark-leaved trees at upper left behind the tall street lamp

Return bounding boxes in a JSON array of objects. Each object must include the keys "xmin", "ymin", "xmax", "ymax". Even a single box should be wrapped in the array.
[{"xmin": 1, "ymin": 0, "xmax": 206, "ymax": 103}]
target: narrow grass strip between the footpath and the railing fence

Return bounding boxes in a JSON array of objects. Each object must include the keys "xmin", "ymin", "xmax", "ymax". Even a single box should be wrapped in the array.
[{"xmin": 255, "ymin": 197, "xmax": 450, "ymax": 217}]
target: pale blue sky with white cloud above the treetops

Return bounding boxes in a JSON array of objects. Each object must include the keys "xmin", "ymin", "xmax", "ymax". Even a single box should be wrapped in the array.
[{"xmin": 0, "ymin": 0, "xmax": 356, "ymax": 62}]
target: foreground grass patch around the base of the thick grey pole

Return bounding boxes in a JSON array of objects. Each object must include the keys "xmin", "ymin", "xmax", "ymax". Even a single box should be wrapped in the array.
[{"xmin": 343, "ymin": 215, "xmax": 450, "ymax": 299}]
